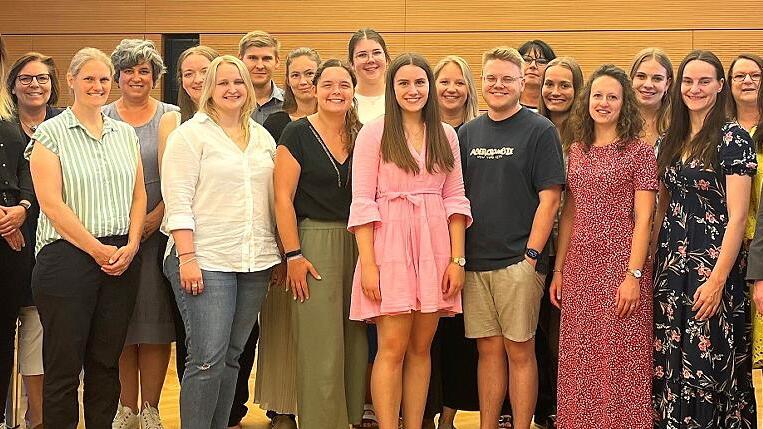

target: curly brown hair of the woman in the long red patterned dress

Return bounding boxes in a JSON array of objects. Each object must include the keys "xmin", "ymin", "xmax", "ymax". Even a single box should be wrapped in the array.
[{"xmin": 572, "ymin": 64, "xmax": 644, "ymax": 151}]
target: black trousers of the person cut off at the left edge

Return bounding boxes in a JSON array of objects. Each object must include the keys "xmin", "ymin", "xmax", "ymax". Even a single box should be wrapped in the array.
[{"xmin": 0, "ymin": 234, "xmax": 33, "ymax": 423}]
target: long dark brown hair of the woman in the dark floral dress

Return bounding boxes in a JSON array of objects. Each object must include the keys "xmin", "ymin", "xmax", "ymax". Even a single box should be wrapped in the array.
[{"xmin": 657, "ymin": 50, "xmax": 730, "ymax": 175}]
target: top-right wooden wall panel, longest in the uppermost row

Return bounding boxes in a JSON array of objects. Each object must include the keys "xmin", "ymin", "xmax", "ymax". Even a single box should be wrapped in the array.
[{"xmin": 405, "ymin": 0, "xmax": 761, "ymax": 32}]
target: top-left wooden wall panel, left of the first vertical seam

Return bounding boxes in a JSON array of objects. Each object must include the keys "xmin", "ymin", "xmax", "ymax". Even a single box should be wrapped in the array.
[{"xmin": 0, "ymin": 0, "xmax": 146, "ymax": 34}]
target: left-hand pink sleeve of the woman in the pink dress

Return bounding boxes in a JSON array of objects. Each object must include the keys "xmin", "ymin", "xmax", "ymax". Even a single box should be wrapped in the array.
[{"xmin": 347, "ymin": 118, "xmax": 384, "ymax": 232}]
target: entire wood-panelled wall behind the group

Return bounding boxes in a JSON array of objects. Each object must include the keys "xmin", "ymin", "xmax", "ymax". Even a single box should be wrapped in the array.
[{"xmin": 0, "ymin": 0, "xmax": 763, "ymax": 104}]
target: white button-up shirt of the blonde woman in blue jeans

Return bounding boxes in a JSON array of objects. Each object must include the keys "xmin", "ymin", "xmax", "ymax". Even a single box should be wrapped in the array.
[{"xmin": 162, "ymin": 113, "xmax": 281, "ymax": 272}]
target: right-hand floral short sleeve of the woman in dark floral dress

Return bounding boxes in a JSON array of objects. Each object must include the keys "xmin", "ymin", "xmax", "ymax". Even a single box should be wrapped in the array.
[{"xmin": 718, "ymin": 123, "xmax": 758, "ymax": 176}]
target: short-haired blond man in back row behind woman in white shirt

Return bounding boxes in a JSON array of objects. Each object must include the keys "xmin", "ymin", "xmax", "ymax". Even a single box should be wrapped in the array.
[{"xmin": 238, "ymin": 31, "xmax": 284, "ymax": 124}]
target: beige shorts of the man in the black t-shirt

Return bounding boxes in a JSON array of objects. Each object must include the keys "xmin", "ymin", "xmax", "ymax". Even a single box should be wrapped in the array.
[{"xmin": 461, "ymin": 259, "xmax": 546, "ymax": 343}]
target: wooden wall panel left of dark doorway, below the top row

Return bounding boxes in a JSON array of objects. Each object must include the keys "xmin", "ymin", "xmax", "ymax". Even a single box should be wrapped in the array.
[{"xmin": 3, "ymin": 34, "xmax": 162, "ymax": 106}]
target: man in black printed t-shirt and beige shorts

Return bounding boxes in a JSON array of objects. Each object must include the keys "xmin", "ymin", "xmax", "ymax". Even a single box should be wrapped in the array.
[{"xmin": 458, "ymin": 47, "xmax": 565, "ymax": 429}]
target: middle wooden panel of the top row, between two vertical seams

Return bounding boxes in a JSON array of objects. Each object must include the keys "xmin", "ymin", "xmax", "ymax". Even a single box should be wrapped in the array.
[{"xmin": 146, "ymin": 0, "xmax": 405, "ymax": 33}]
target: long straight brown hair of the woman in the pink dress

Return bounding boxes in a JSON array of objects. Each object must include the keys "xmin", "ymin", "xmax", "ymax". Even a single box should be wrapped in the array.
[{"xmin": 381, "ymin": 53, "xmax": 455, "ymax": 174}]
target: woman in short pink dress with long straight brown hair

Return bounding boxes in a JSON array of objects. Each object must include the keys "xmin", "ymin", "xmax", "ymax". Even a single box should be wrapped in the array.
[{"xmin": 348, "ymin": 54, "xmax": 471, "ymax": 429}]
